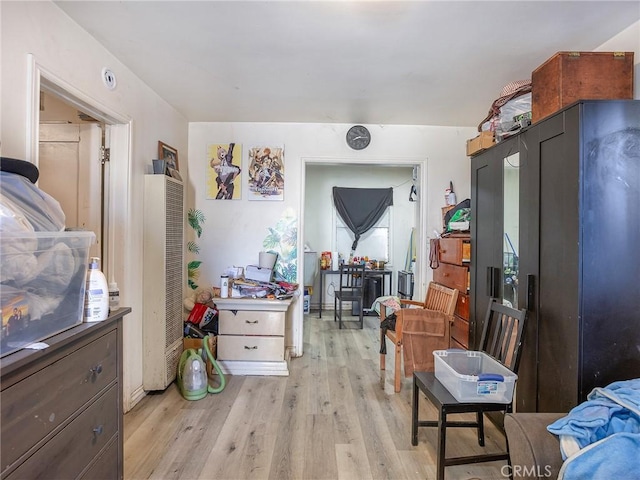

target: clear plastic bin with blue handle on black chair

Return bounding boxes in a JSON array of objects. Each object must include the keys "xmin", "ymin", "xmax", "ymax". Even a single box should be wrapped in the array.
[{"xmin": 433, "ymin": 350, "xmax": 518, "ymax": 403}]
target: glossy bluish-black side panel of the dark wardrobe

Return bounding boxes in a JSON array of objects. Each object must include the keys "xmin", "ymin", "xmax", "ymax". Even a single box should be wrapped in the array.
[{"xmin": 577, "ymin": 101, "xmax": 640, "ymax": 401}]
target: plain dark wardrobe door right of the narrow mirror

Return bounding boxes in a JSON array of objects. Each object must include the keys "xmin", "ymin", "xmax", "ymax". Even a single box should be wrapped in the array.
[{"xmin": 537, "ymin": 106, "xmax": 580, "ymax": 412}]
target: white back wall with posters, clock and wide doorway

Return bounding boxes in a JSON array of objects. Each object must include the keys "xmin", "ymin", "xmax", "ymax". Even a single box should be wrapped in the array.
[{"xmin": 187, "ymin": 123, "xmax": 476, "ymax": 355}]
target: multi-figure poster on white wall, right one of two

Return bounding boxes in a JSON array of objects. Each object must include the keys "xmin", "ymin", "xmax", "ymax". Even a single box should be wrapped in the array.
[{"xmin": 249, "ymin": 147, "xmax": 284, "ymax": 200}]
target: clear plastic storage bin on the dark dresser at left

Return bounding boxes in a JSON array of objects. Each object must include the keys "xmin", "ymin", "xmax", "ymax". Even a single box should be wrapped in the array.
[{"xmin": 0, "ymin": 231, "xmax": 95, "ymax": 356}]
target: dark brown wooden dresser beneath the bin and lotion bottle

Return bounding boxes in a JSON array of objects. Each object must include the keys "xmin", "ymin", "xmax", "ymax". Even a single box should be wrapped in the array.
[{"xmin": 0, "ymin": 308, "xmax": 131, "ymax": 480}]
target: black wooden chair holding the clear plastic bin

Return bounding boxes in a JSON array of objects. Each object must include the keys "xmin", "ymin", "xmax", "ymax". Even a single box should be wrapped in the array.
[{"xmin": 411, "ymin": 299, "xmax": 527, "ymax": 480}]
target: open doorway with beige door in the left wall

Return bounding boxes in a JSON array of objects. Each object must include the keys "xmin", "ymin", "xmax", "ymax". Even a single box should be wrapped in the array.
[{"xmin": 28, "ymin": 68, "xmax": 130, "ymax": 289}]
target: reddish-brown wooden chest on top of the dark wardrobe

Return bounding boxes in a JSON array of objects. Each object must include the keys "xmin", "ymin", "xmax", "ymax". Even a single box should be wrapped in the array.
[{"xmin": 531, "ymin": 52, "xmax": 634, "ymax": 122}]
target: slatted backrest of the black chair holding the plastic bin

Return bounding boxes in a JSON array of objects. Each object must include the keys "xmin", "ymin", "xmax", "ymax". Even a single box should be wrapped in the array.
[{"xmin": 480, "ymin": 299, "xmax": 527, "ymax": 373}]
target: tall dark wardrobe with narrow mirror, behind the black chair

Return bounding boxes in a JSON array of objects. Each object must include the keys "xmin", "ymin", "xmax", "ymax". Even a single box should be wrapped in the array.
[{"xmin": 470, "ymin": 100, "xmax": 640, "ymax": 412}]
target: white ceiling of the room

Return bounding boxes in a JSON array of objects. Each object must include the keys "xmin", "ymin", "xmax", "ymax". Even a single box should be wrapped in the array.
[{"xmin": 56, "ymin": 0, "xmax": 640, "ymax": 126}]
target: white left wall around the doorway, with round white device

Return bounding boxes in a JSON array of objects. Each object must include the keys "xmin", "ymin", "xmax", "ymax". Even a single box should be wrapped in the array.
[{"xmin": 0, "ymin": 2, "xmax": 188, "ymax": 409}]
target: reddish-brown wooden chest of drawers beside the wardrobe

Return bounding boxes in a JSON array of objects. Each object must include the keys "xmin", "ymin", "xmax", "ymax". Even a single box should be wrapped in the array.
[{"xmin": 433, "ymin": 233, "xmax": 471, "ymax": 349}]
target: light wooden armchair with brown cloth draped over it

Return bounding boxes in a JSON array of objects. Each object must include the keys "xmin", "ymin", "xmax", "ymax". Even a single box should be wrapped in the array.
[{"xmin": 380, "ymin": 282, "xmax": 458, "ymax": 393}]
